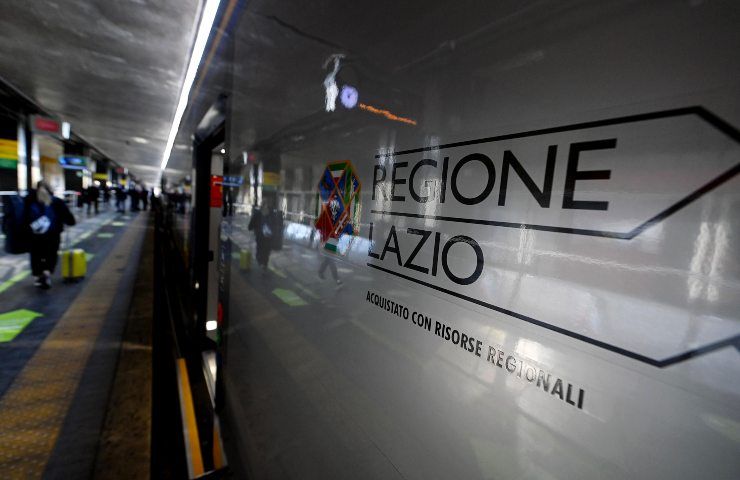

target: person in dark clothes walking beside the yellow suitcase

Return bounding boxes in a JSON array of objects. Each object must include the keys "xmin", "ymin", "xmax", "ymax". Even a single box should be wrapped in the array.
[{"xmin": 24, "ymin": 180, "xmax": 76, "ymax": 290}]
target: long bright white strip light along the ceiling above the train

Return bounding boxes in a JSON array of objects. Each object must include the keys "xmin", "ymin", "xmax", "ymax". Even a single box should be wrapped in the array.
[{"xmin": 159, "ymin": 0, "xmax": 220, "ymax": 171}]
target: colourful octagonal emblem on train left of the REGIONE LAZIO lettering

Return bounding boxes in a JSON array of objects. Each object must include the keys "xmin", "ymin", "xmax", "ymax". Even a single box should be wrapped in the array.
[{"xmin": 316, "ymin": 160, "xmax": 361, "ymax": 255}]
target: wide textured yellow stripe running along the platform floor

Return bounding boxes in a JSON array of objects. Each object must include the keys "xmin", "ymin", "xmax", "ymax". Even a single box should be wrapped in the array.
[{"xmin": 0, "ymin": 216, "xmax": 145, "ymax": 478}]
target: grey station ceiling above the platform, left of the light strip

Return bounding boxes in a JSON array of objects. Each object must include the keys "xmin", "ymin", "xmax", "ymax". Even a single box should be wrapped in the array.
[{"xmin": 0, "ymin": 0, "xmax": 200, "ymax": 183}]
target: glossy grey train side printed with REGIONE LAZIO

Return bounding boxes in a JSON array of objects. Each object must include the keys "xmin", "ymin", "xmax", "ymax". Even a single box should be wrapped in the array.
[{"xmin": 168, "ymin": 0, "xmax": 740, "ymax": 479}]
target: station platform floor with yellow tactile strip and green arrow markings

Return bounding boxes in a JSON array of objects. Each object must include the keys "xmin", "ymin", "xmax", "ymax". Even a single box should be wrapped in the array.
[{"xmin": 0, "ymin": 209, "xmax": 154, "ymax": 479}]
